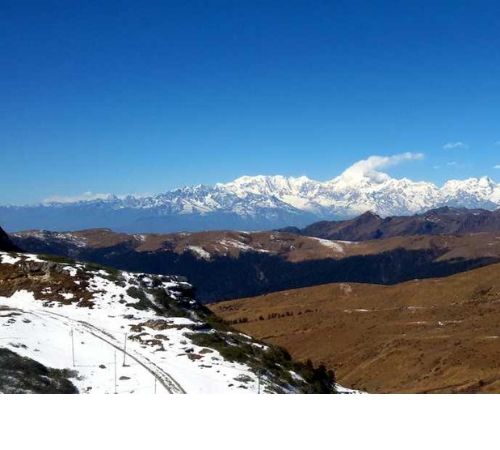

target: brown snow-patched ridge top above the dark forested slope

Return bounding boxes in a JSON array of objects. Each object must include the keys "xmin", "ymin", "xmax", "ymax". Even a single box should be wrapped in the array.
[{"xmin": 13, "ymin": 228, "xmax": 500, "ymax": 262}]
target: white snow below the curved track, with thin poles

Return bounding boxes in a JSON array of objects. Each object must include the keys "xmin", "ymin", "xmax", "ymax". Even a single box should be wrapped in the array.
[{"xmin": 0, "ymin": 304, "xmax": 167, "ymax": 394}]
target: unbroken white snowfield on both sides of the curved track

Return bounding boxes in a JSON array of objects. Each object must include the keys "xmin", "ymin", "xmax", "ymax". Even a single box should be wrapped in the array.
[{"xmin": 0, "ymin": 288, "xmax": 264, "ymax": 393}]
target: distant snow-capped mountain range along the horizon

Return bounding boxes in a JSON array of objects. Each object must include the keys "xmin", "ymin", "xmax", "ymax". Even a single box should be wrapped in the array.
[{"xmin": 0, "ymin": 165, "xmax": 500, "ymax": 232}]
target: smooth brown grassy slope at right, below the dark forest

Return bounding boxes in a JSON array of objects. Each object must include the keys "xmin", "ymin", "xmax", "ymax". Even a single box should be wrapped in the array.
[{"xmin": 210, "ymin": 264, "xmax": 500, "ymax": 393}]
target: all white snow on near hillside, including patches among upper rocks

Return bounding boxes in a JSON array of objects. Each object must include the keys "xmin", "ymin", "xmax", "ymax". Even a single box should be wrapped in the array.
[{"xmin": 0, "ymin": 253, "xmax": 320, "ymax": 393}]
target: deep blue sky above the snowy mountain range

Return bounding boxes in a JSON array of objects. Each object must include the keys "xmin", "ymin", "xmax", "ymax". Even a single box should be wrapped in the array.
[{"xmin": 0, "ymin": 0, "xmax": 500, "ymax": 204}]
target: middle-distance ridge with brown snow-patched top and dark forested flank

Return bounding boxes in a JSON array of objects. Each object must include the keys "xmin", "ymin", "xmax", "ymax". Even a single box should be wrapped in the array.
[{"xmin": 12, "ymin": 225, "xmax": 500, "ymax": 302}]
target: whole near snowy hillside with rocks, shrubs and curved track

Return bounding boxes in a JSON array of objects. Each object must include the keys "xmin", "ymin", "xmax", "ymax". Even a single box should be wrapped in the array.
[{"xmin": 0, "ymin": 252, "xmax": 334, "ymax": 393}]
